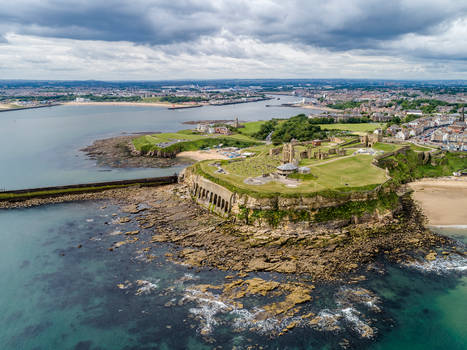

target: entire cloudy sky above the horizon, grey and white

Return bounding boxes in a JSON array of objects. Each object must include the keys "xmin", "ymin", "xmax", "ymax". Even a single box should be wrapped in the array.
[{"xmin": 0, "ymin": 0, "xmax": 467, "ymax": 80}]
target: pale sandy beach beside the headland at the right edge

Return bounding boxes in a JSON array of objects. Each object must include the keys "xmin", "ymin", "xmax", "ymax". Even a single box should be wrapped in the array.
[{"xmin": 409, "ymin": 177, "xmax": 467, "ymax": 226}]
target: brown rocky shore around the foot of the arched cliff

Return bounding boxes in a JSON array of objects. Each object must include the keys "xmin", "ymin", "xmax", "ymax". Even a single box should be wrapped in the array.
[{"xmin": 0, "ymin": 184, "xmax": 465, "ymax": 282}]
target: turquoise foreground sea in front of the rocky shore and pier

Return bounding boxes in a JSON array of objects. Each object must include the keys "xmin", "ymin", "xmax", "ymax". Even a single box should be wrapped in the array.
[{"xmin": 0, "ymin": 202, "xmax": 467, "ymax": 349}]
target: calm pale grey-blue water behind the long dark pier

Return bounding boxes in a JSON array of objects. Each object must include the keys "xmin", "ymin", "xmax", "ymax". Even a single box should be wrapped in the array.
[{"xmin": 0, "ymin": 96, "xmax": 310, "ymax": 190}]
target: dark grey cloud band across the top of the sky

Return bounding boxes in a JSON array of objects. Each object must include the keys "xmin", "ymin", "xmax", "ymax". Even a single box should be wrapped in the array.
[{"xmin": 0, "ymin": 0, "xmax": 467, "ymax": 51}]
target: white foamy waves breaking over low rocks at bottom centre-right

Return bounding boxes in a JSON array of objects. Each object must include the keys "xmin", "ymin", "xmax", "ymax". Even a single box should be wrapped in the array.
[{"xmin": 182, "ymin": 287, "xmax": 381, "ymax": 338}]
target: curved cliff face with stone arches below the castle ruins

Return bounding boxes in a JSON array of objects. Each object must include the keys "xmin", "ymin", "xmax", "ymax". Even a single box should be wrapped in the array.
[{"xmin": 182, "ymin": 168, "xmax": 398, "ymax": 226}]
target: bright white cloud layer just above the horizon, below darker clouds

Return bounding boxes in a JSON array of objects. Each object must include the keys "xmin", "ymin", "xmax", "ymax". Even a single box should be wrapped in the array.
[{"xmin": 0, "ymin": 32, "xmax": 467, "ymax": 80}]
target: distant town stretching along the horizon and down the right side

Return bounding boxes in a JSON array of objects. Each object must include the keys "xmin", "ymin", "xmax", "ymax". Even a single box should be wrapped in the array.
[{"xmin": 0, "ymin": 80, "xmax": 467, "ymax": 151}]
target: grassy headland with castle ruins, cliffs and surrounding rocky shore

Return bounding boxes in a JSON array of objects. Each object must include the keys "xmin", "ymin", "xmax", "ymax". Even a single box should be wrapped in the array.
[{"xmin": 2, "ymin": 116, "xmax": 466, "ymax": 282}]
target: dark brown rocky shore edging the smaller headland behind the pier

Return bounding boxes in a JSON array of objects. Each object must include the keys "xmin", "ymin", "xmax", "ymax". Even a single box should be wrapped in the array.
[{"xmin": 80, "ymin": 133, "xmax": 193, "ymax": 168}]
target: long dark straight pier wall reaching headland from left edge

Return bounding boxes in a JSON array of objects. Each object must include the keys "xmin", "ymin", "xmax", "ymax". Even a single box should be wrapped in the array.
[{"xmin": 0, "ymin": 174, "xmax": 178, "ymax": 202}]
